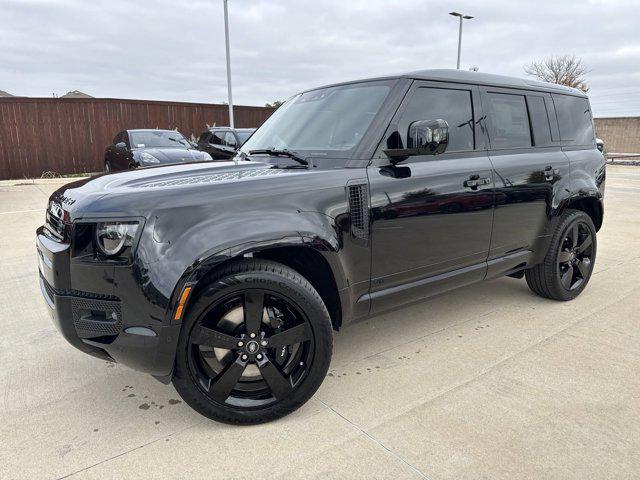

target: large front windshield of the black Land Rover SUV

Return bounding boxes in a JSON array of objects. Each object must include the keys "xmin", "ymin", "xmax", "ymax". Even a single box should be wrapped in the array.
[{"xmin": 241, "ymin": 81, "xmax": 392, "ymax": 156}]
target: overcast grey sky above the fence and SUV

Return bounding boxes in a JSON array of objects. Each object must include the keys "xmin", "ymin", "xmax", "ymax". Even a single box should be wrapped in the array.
[{"xmin": 0, "ymin": 0, "xmax": 640, "ymax": 116}]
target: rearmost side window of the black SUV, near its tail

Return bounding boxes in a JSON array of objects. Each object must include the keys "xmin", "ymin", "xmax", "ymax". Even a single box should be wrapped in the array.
[{"xmin": 552, "ymin": 94, "xmax": 595, "ymax": 145}]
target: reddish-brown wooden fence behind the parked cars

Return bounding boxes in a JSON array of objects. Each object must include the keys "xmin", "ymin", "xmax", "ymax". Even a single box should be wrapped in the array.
[{"xmin": 0, "ymin": 98, "xmax": 274, "ymax": 179}]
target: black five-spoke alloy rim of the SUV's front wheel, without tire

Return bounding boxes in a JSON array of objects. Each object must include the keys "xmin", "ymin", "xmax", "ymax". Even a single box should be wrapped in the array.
[{"xmin": 189, "ymin": 289, "xmax": 313, "ymax": 408}]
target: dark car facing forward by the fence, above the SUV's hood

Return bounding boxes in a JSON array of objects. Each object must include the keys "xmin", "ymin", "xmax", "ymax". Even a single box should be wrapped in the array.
[{"xmin": 104, "ymin": 129, "xmax": 211, "ymax": 173}]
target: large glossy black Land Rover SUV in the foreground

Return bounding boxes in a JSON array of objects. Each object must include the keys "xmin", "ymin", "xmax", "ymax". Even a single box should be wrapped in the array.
[{"xmin": 37, "ymin": 70, "xmax": 605, "ymax": 423}]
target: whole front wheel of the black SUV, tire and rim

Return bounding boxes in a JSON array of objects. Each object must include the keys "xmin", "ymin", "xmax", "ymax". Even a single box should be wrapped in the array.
[{"xmin": 173, "ymin": 259, "xmax": 333, "ymax": 425}]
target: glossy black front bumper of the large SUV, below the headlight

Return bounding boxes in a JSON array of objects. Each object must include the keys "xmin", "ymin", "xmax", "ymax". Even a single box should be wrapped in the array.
[{"xmin": 36, "ymin": 227, "xmax": 180, "ymax": 382}]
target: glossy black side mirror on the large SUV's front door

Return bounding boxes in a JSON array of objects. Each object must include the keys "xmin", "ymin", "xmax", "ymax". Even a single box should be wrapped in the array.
[{"xmin": 384, "ymin": 119, "xmax": 449, "ymax": 163}]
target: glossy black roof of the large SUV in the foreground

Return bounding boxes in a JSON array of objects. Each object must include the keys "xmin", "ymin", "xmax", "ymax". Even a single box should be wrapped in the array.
[{"xmin": 314, "ymin": 69, "xmax": 587, "ymax": 97}]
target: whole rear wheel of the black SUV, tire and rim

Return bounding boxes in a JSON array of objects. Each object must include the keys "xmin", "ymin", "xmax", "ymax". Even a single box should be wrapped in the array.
[{"xmin": 525, "ymin": 210, "xmax": 597, "ymax": 301}]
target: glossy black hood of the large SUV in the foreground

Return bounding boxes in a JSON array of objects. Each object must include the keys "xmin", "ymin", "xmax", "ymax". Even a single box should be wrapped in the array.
[{"xmin": 50, "ymin": 161, "xmax": 312, "ymax": 220}]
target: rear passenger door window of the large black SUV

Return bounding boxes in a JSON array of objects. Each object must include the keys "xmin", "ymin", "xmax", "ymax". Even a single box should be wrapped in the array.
[{"xmin": 487, "ymin": 93, "xmax": 532, "ymax": 148}]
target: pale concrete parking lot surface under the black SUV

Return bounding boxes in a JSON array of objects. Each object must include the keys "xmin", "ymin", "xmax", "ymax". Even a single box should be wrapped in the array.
[{"xmin": 0, "ymin": 166, "xmax": 640, "ymax": 479}]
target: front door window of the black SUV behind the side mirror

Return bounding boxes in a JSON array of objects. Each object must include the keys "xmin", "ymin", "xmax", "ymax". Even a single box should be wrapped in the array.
[{"xmin": 398, "ymin": 87, "xmax": 475, "ymax": 152}]
